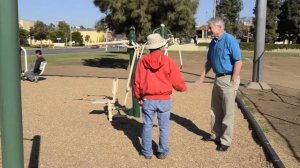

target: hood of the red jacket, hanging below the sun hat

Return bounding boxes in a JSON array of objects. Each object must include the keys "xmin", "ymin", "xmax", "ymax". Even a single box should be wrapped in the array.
[{"xmin": 142, "ymin": 50, "xmax": 165, "ymax": 70}]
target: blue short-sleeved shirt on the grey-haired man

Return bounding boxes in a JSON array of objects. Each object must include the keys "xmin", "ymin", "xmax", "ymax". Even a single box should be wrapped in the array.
[{"xmin": 207, "ymin": 32, "xmax": 242, "ymax": 74}]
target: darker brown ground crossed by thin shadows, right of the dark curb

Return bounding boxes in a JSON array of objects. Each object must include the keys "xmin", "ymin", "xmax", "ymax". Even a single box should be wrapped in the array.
[{"xmin": 240, "ymin": 81, "xmax": 300, "ymax": 167}]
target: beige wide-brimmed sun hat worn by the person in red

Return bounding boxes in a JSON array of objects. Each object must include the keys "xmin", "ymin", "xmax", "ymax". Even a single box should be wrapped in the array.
[{"xmin": 145, "ymin": 33, "xmax": 168, "ymax": 49}]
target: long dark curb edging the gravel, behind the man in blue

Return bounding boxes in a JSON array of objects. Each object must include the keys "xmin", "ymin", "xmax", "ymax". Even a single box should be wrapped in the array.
[{"xmin": 236, "ymin": 94, "xmax": 285, "ymax": 168}]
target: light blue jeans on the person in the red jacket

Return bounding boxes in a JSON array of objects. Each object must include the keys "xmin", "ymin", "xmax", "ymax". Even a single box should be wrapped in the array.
[{"xmin": 141, "ymin": 100, "xmax": 171, "ymax": 156}]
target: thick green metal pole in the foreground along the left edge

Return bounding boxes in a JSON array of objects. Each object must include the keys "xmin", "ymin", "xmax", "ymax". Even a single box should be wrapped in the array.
[{"xmin": 0, "ymin": 0, "xmax": 24, "ymax": 168}]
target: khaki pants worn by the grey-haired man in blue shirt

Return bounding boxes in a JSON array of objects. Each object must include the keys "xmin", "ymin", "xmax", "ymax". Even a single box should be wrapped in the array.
[{"xmin": 211, "ymin": 75, "xmax": 240, "ymax": 146}]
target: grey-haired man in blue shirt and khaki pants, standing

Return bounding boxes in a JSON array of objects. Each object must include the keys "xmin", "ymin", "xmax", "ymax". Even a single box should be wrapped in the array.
[{"xmin": 196, "ymin": 17, "xmax": 242, "ymax": 151}]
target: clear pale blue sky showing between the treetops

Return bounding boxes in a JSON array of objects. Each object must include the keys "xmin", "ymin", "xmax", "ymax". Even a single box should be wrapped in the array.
[{"xmin": 18, "ymin": 0, "xmax": 256, "ymax": 28}]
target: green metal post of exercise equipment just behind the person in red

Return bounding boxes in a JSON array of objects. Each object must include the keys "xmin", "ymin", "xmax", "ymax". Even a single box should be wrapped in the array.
[{"xmin": 128, "ymin": 27, "xmax": 141, "ymax": 117}]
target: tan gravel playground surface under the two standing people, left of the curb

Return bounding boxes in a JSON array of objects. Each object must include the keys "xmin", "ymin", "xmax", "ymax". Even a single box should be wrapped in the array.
[{"xmin": 7, "ymin": 76, "xmax": 272, "ymax": 168}]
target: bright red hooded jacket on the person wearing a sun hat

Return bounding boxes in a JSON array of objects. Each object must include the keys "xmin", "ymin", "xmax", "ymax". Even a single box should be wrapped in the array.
[{"xmin": 133, "ymin": 50, "xmax": 187, "ymax": 100}]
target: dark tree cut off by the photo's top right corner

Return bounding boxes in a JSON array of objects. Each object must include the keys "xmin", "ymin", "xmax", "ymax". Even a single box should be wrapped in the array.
[{"xmin": 277, "ymin": 0, "xmax": 300, "ymax": 43}]
